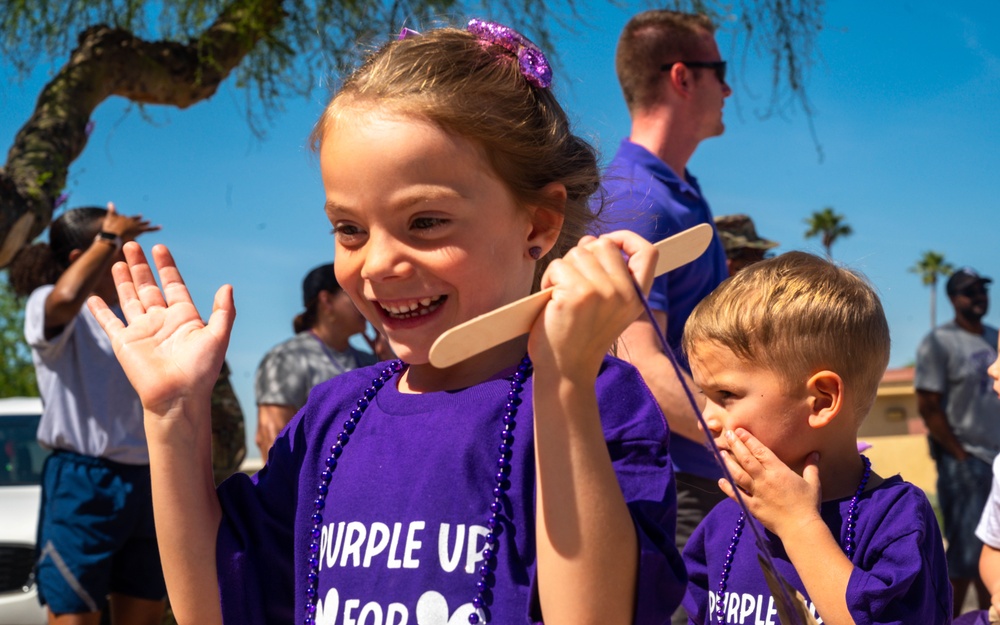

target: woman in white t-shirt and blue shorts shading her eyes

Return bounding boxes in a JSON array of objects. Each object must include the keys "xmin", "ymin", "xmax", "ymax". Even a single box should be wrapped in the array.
[{"xmin": 10, "ymin": 204, "xmax": 164, "ymax": 625}]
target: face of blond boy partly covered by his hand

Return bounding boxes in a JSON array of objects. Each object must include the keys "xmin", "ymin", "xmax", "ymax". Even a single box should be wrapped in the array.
[{"xmin": 690, "ymin": 342, "xmax": 815, "ymax": 471}]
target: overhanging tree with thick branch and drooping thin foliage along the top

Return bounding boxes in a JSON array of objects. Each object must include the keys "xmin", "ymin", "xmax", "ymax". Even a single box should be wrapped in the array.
[{"xmin": 0, "ymin": 0, "xmax": 823, "ymax": 267}]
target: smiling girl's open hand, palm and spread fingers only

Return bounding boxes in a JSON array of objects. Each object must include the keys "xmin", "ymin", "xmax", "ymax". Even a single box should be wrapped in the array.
[{"xmin": 87, "ymin": 242, "xmax": 236, "ymax": 416}]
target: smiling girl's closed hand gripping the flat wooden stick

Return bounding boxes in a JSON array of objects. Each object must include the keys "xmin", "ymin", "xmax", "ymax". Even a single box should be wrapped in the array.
[{"xmin": 528, "ymin": 231, "xmax": 658, "ymax": 376}]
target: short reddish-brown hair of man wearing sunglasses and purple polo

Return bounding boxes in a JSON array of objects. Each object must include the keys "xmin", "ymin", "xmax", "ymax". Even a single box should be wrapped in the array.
[{"xmin": 615, "ymin": 9, "xmax": 715, "ymax": 112}]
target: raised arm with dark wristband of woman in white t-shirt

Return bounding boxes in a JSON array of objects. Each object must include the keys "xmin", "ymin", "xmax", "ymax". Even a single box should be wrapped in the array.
[{"xmin": 45, "ymin": 203, "xmax": 159, "ymax": 339}]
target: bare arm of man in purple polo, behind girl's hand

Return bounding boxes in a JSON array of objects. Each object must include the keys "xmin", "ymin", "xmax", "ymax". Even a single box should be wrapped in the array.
[{"xmin": 617, "ymin": 310, "xmax": 705, "ymax": 442}]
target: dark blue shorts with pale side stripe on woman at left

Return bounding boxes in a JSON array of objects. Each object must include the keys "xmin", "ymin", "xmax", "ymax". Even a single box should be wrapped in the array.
[{"xmin": 37, "ymin": 451, "xmax": 167, "ymax": 614}]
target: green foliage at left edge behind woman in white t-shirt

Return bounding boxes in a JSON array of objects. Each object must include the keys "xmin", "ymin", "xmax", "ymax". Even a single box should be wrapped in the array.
[{"xmin": 0, "ymin": 272, "xmax": 38, "ymax": 397}]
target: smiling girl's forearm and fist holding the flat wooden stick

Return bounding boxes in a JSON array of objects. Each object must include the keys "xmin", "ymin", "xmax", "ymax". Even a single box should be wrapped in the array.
[{"xmin": 528, "ymin": 233, "xmax": 656, "ymax": 625}]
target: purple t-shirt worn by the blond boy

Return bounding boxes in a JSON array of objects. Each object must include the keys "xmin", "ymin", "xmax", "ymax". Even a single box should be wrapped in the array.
[{"xmin": 684, "ymin": 476, "xmax": 951, "ymax": 625}]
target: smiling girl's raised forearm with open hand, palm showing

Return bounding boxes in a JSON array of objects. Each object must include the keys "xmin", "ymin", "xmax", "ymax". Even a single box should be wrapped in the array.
[{"xmin": 88, "ymin": 243, "xmax": 236, "ymax": 625}]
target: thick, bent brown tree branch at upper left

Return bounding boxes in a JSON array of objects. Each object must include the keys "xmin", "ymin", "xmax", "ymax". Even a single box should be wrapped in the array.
[{"xmin": 0, "ymin": 0, "xmax": 285, "ymax": 267}]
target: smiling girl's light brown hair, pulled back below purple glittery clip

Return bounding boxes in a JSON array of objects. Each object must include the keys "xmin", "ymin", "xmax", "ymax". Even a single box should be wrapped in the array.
[{"xmin": 311, "ymin": 23, "xmax": 600, "ymax": 288}]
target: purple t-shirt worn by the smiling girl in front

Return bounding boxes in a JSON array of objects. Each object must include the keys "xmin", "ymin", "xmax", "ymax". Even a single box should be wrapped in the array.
[{"xmin": 217, "ymin": 357, "xmax": 685, "ymax": 625}]
